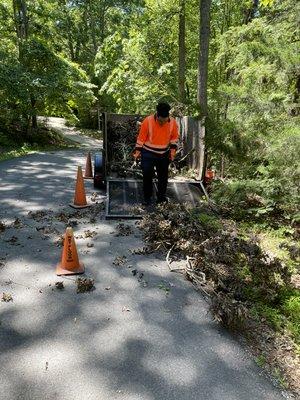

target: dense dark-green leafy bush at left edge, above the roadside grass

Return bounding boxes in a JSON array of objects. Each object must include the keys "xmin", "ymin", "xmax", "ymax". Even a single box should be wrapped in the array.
[{"xmin": 0, "ymin": 38, "xmax": 94, "ymax": 134}]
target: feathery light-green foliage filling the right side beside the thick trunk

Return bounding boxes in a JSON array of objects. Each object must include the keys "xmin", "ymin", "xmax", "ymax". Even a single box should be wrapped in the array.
[{"xmin": 206, "ymin": 0, "xmax": 300, "ymax": 220}]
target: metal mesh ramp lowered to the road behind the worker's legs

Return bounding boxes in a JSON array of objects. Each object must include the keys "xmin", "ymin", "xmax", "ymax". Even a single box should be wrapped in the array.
[{"xmin": 106, "ymin": 179, "xmax": 204, "ymax": 218}]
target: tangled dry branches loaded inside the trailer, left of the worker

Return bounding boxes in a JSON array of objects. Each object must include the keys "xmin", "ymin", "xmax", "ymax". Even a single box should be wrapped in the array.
[{"xmin": 107, "ymin": 117, "xmax": 140, "ymax": 177}]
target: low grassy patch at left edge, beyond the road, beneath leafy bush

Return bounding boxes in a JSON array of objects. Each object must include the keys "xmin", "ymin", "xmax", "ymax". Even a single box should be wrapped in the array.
[{"xmin": 0, "ymin": 128, "xmax": 79, "ymax": 161}]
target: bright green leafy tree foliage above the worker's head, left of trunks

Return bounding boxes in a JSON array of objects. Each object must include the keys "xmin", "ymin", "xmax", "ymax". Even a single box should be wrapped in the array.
[{"xmin": 95, "ymin": 0, "xmax": 192, "ymax": 114}]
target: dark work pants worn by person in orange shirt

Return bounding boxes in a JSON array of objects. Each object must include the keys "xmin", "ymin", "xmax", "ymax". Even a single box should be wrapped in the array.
[{"xmin": 141, "ymin": 149, "xmax": 169, "ymax": 202}]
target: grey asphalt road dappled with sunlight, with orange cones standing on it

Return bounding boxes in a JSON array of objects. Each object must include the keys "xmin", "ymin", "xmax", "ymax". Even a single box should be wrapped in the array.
[{"xmin": 0, "ymin": 137, "xmax": 283, "ymax": 400}]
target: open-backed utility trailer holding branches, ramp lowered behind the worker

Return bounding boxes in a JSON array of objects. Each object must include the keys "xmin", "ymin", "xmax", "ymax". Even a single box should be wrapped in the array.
[{"xmin": 94, "ymin": 113, "xmax": 206, "ymax": 219}]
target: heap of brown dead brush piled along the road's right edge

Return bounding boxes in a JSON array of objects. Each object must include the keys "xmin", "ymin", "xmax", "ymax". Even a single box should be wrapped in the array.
[{"xmin": 141, "ymin": 204, "xmax": 291, "ymax": 318}]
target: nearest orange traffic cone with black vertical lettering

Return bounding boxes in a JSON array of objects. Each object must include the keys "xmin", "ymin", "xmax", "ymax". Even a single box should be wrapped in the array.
[{"xmin": 56, "ymin": 228, "xmax": 84, "ymax": 275}]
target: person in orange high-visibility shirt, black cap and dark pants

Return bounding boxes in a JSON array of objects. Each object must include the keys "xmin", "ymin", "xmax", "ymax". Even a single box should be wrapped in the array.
[{"xmin": 133, "ymin": 103, "xmax": 179, "ymax": 206}]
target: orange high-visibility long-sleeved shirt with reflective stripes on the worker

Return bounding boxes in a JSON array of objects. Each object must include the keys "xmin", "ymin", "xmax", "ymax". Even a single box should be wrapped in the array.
[{"xmin": 135, "ymin": 115, "xmax": 179, "ymax": 154}]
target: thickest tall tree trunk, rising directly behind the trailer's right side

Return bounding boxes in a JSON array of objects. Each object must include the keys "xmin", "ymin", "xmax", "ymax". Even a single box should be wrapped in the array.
[{"xmin": 197, "ymin": 0, "xmax": 211, "ymax": 179}]
